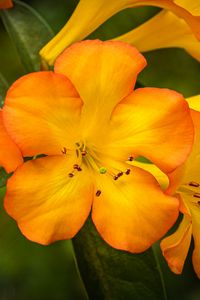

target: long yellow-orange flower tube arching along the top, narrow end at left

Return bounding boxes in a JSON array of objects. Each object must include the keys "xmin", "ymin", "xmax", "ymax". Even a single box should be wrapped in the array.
[{"xmin": 40, "ymin": 0, "xmax": 200, "ymax": 65}]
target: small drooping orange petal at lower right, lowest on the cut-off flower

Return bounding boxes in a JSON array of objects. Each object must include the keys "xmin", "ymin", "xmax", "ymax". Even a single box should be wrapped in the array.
[{"xmin": 161, "ymin": 216, "xmax": 192, "ymax": 274}]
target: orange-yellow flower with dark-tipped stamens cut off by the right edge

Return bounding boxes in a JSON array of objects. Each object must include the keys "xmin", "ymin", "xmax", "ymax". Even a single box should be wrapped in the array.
[{"xmin": 161, "ymin": 96, "xmax": 200, "ymax": 278}]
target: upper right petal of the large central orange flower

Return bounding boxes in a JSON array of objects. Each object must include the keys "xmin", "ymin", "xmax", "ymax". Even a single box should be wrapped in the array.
[{"xmin": 108, "ymin": 88, "xmax": 193, "ymax": 173}]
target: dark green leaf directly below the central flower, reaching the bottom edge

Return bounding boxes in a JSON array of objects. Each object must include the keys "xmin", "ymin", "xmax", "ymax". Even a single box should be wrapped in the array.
[{"xmin": 73, "ymin": 218, "xmax": 166, "ymax": 300}]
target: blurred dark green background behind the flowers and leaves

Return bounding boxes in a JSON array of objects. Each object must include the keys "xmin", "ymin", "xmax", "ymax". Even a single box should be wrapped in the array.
[{"xmin": 0, "ymin": 0, "xmax": 200, "ymax": 300}]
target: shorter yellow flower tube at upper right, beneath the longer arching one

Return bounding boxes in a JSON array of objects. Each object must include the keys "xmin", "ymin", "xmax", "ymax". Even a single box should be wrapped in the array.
[{"xmin": 114, "ymin": 10, "xmax": 200, "ymax": 61}]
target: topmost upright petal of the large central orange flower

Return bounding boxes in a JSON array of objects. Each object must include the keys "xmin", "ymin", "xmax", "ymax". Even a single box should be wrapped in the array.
[{"xmin": 55, "ymin": 40, "xmax": 146, "ymax": 131}]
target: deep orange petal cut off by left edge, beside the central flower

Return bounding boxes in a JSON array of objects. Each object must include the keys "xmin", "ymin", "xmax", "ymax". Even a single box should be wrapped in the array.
[{"xmin": 0, "ymin": 110, "xmax": 23, "ymax": 173}]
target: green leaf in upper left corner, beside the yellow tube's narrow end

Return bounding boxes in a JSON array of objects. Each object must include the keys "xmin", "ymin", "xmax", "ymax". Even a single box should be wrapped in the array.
[{"xmin": 1, "ymin": 1, "xmax": 53, "ymax": 72}]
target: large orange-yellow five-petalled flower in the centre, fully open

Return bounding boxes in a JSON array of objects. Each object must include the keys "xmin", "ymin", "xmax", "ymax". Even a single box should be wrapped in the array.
[{"xmin": 3, "ymin": 40, "xmax": 193, "ymax": 252}]
